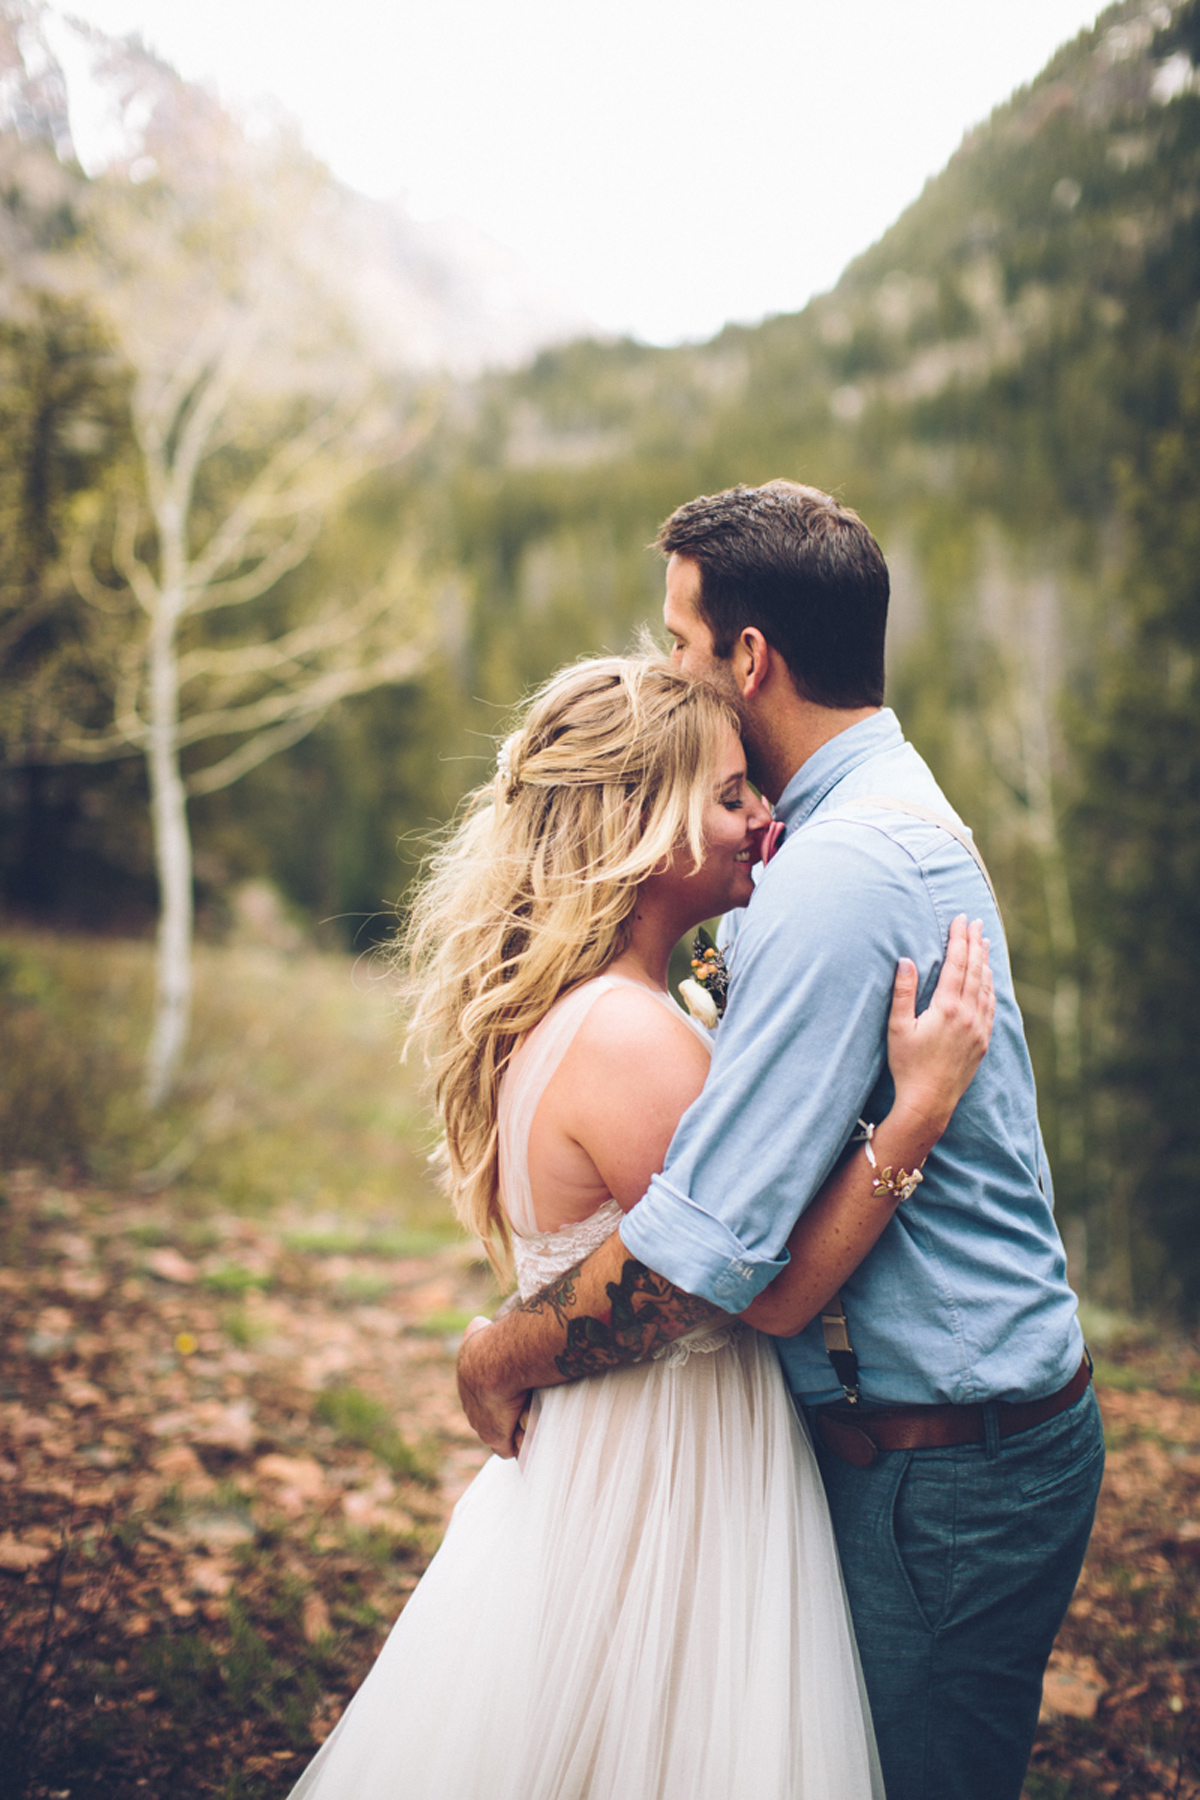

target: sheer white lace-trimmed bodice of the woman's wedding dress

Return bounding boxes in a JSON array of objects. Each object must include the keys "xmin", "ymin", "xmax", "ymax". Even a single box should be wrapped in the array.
[{"xmin": 500, "ymin": 976, "xmax": 739, "ymax": 1364}]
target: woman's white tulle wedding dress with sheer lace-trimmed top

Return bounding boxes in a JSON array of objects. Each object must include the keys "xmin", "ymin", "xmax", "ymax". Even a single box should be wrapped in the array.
[{"xmin": 291, "ymin": 976, "xmax": 883, "ymax": 1800}]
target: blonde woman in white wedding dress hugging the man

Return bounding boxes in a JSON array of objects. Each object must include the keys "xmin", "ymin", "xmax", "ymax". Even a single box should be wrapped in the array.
[{"xmin": 293, "ymin": 659, "xmax": 991, "ymax": 1800}]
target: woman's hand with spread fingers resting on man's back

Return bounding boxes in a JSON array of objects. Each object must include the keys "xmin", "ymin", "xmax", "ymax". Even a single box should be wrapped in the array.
[{"xmin": 887, "ymin": 914, "xmax": 997, "ymax": 1136}]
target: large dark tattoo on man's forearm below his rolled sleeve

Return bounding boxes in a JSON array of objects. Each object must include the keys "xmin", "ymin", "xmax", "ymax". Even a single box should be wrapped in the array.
[{"xmin": 522, "ymin": 1256, "xmax": 720, "ymax": 1381}]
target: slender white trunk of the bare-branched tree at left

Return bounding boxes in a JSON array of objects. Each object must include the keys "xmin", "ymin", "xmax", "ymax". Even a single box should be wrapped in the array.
[{"xmin": 146, "ymin": 590, "xmax": 193, "ymax": 1107}]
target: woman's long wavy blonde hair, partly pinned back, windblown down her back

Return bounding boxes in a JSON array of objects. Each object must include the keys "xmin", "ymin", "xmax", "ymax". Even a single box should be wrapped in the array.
[{"xmin": 398, "ymin": 657, "xmax": 738, "ymax": 1274}]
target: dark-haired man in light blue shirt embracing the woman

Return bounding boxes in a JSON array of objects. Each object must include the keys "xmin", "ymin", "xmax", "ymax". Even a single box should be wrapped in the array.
[{"xmin": 459, "ymin": 481, "xmax": 1103, "ymax": 1800}]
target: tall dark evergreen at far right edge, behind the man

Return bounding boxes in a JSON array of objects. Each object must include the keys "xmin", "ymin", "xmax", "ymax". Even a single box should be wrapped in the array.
[{"xmin": 1078, "ymin": 346, "xmax": 1200, "ymax": 1316}]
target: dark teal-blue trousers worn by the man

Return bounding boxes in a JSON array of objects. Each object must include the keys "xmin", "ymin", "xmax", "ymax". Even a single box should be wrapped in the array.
[{"xmin": 813, "ymin": 1388, "xmax": 1105, "ymax": 1800}]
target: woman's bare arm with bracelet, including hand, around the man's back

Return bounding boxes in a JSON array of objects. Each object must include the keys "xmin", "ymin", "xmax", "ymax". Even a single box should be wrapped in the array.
[{"xmin": 741, "ymin": 940, "xmax": 995, "ymax": 1337}]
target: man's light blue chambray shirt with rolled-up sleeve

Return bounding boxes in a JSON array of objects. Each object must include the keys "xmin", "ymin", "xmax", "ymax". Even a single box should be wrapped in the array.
[{"xmin": 621, "ymin": 709, "xmax": 1083, "ymax": 1406}]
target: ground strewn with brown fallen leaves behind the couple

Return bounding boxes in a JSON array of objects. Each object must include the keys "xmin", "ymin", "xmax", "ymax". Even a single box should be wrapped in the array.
[{"xmin": 0, "ymin": 1172, "xmax": 1200, "ymax": 1800}]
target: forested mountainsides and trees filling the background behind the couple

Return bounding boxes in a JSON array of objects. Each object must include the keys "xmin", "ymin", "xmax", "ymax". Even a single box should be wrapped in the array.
[{"xmin": 0, "ymin": 0, "xmax": 1200, "ymax": 1318}]
